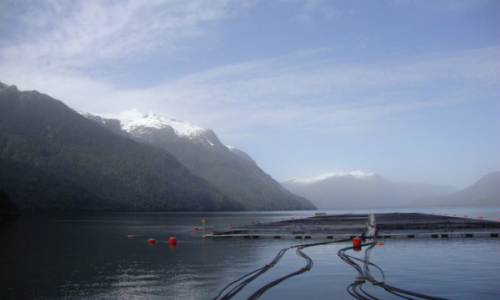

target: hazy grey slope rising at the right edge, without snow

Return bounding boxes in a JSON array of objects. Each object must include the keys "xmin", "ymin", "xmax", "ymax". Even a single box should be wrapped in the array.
[{"xmin": 426, "ymin": 172, "xmax": 500, "ymax": 206}]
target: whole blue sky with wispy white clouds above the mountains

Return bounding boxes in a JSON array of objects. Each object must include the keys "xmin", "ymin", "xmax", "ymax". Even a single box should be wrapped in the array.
[{"xmin": 0, "ymin": 0, "xmax": 500, "ymax": 189}]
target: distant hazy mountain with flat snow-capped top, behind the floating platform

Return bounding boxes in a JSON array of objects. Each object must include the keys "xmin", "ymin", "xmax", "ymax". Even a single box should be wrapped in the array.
[{"xmin": 282, "ymin": 171, "xmax": 455, "ymax": 209}]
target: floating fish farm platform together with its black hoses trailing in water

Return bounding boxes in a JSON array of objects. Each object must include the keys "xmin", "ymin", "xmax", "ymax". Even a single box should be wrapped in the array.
[{"xmin": 211, "ymin": 213, "xmax": 500, "ymax": 300}]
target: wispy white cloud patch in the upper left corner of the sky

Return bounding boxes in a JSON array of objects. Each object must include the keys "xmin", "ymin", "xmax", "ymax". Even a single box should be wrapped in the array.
[{"xmin": 1, "ymin": 0, "xmax": 245, "ymax": 71}]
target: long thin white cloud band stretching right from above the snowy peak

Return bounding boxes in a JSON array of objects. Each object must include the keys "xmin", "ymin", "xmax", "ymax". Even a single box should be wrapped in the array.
[{"xmin": 2, "ymin": 47, "xmax": 500, "ymax": 134}]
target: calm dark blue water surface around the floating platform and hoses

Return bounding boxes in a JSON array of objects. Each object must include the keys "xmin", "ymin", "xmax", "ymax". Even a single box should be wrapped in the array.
[{"xmin": 0, "ymin": 207, "xmax": 500, "ymax": 299}]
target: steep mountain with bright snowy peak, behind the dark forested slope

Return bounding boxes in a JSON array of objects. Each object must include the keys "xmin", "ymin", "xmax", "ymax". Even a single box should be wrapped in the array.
[{"xmin": 85, "ymin": 111, "xmax": 316, "ymax": 210}]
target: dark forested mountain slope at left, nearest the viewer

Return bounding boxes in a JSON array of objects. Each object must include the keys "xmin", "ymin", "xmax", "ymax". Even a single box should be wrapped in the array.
[{"xmin": 0, "ymin": 83, "xmax": 244, "ymax": 211}]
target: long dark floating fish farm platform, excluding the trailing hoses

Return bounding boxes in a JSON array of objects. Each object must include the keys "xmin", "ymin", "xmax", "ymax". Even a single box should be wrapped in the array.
[{"xmin": 204, "ymin": 213, "xmax": 500, "ymax": 239}]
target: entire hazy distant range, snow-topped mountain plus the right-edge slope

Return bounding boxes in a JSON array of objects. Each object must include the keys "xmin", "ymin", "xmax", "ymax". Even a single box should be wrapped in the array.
[{"xmin": 282, "ymin": 171, "xmax": 500, "ymax": 209}]
